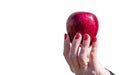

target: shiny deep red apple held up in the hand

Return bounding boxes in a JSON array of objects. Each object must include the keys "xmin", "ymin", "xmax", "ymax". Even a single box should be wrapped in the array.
[{"xmin": 66, "ymin": 12, "xmax": 98, "ymax": 45}]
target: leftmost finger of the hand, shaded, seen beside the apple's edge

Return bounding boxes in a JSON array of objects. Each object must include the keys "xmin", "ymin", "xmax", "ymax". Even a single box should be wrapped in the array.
[{"xmin": 63, "ymin": 34, "xmax": 74, "ymax": 72}]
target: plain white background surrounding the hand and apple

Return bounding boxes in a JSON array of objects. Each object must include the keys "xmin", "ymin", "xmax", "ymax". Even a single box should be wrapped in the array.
[{"xmin": 0, "ymin": 0, "xmax": 120, "ymax": 75}]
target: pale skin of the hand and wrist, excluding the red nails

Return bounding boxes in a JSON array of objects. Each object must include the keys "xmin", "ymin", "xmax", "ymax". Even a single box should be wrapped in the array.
[{"xmin": 63, "ymin": 33, "xmax": 110, "ymax": 75}]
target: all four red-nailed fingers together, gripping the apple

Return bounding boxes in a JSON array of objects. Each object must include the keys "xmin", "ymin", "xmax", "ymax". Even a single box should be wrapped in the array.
[{"xmin": 63, "ymin": 33, "xmax": 98, "ymax": 74}]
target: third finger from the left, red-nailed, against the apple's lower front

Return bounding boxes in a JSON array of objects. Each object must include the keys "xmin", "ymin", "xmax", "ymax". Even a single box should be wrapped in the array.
[{"xmin": 79, "ymin": 34, "xmax": 90, "ymax": 70}]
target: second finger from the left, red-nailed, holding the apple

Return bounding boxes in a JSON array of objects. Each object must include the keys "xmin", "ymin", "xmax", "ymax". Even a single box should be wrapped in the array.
[{"xmin": 69, "ymin": 33, "xmax": 82, "ymax": 71}]
